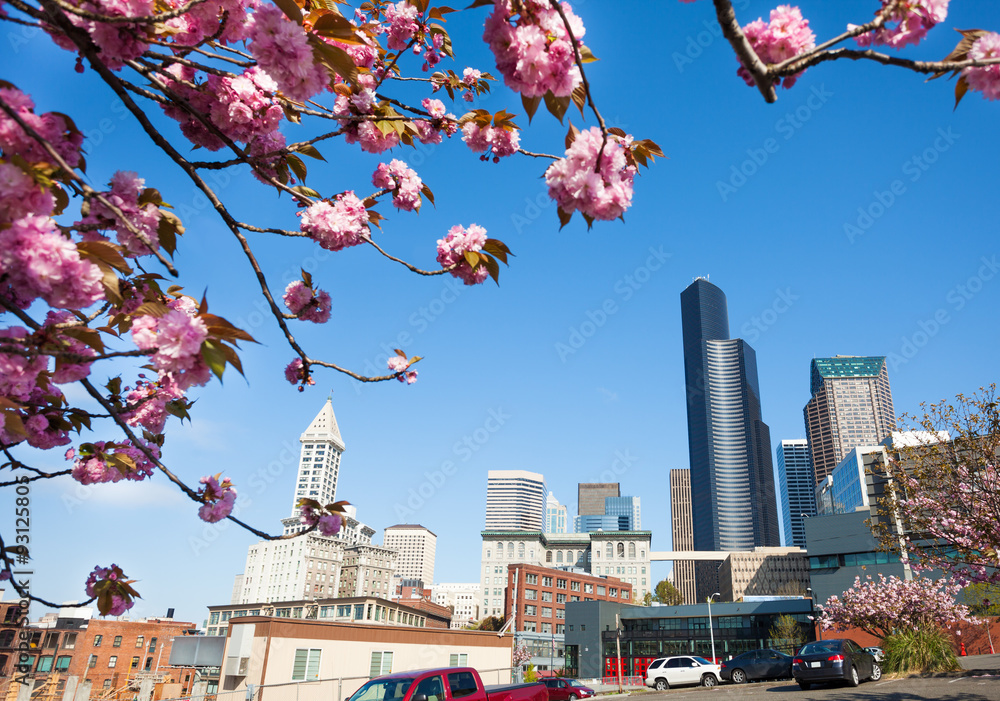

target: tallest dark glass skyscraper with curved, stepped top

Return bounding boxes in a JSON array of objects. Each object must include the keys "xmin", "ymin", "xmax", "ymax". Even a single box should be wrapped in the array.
[{"xmin": 681, "ymin": 278, "xmax": 780, "ymax": 560}]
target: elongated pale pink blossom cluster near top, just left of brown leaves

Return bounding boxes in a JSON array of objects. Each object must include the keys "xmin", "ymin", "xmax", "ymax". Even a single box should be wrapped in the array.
[{"xmin": 249, "ymin": 3, "xmax": 330, "ymax": 101}]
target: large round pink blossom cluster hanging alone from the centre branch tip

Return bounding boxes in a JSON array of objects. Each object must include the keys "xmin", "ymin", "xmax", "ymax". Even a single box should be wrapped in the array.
[{"xmin": 545, "ymin": 127, "xmax": 636, "ymax": 220}]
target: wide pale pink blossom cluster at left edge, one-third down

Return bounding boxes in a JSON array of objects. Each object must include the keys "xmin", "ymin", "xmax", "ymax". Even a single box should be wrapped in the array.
[{"xmin": 0, "ymin": 215, "xmax": 104, "ymax": 309}]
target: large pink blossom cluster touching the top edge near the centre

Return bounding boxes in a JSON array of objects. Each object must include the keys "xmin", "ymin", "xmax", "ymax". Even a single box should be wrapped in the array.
[{"xmin": 483, "ymin": 0, "xmax": 585, "ymax": 97}]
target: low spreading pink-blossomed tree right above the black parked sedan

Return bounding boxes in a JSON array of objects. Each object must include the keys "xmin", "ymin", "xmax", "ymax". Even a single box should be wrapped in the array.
[{"xmin": 820, "ymin": 574, "xmax": 977, "ymax": 638}]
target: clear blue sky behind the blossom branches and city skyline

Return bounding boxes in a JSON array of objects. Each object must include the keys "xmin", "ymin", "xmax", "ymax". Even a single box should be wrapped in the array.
[{"xmin": 0, "ymin": 0, "xmax": 1000, "ymax": 621}]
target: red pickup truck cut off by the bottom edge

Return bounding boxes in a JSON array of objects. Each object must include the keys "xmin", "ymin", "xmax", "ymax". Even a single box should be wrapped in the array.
[{"xmin": 347, "ymin": 667, "xmax": 548, "ymax": 701}]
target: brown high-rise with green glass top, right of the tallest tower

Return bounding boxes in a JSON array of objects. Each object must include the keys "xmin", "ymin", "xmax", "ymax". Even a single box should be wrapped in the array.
[{"xmin": 803, "ymin": 355, "xmax": 896, "ymax": 485}]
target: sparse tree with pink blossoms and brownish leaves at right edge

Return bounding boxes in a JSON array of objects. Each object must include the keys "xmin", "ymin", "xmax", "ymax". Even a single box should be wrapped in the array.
[{"xmin": 876, "ymin": 385, "xmax": 1000, "ymax": 585}]
